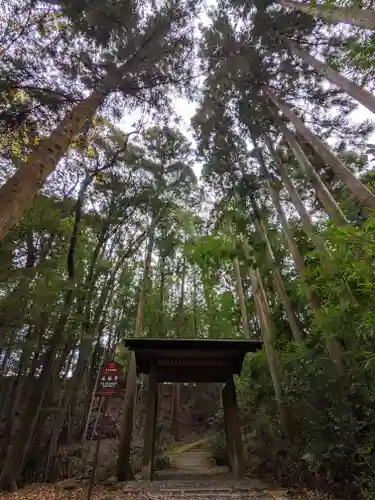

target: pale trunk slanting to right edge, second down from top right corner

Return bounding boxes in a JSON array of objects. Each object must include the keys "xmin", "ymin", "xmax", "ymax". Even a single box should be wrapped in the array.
[{"xmin": 284, "ymin": 38, "xmax": 375, "ymax": 113}]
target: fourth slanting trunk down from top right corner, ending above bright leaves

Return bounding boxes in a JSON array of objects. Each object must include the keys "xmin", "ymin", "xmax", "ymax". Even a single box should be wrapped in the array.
[{"xmin": 275, "ymin": 117, "xmax": 348, "ymax": 226}]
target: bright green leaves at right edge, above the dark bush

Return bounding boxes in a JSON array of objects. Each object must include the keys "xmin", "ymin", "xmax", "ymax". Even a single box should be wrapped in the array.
[{"xmin": 302, "ymin": 221, "xmax": 375, "ymax": 349}]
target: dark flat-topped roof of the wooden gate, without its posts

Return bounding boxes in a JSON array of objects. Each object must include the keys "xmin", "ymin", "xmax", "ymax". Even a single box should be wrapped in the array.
[{"xmin": 125, "ymin": 338, "xmax": 263, "ymax": 382}]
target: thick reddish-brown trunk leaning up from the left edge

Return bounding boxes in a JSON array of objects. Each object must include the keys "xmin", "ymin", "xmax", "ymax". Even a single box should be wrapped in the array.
[{"xmin": 0, "ymin": 85, "xmax": 108, "ymax": 240}]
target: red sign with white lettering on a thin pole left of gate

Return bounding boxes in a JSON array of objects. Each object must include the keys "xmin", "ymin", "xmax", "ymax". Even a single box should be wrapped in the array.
[{"xmin": 86, "ymin": 361, "xmax": 121, "ymax": 500}]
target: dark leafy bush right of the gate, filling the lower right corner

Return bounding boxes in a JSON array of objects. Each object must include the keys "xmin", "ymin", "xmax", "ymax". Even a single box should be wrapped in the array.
[{"xmin": 237, "ymin": 350, "xmax": 375, "ymax": 498}]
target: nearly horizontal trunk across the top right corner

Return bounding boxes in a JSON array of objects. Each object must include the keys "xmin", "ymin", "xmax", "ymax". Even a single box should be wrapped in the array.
[{"xmin": 279, "ymin": 0, "xmax": 375, "ymax": 30}]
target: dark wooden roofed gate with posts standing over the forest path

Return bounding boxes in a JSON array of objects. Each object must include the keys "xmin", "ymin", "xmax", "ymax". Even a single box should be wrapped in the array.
[{"xmin": 118, "ymin": 338, "xmax": 263, "ymax": 481}]
